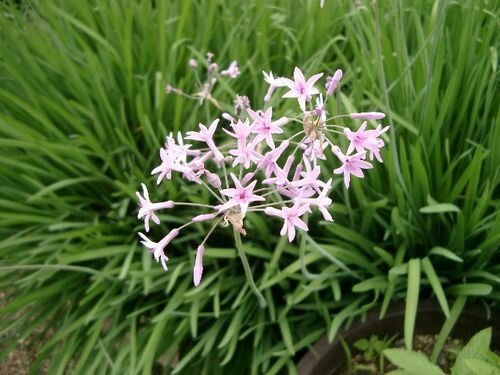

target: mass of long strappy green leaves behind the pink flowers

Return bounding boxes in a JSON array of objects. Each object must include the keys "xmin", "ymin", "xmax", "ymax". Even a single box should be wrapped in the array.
[{"xmin": 0, "ymin": 0, "xmax": 500, "ymax": 374}]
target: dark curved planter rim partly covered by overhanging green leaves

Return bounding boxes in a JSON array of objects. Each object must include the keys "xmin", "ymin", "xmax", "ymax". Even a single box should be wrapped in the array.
[{"xmin": 298, "ymin": 301, "xmax": 500, "ymax": 375}]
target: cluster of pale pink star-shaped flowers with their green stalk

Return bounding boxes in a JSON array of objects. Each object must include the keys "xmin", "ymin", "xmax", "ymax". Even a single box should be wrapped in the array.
[{"xmin": 137, "ymin": 53, "xmax": 389, "ymax": 306}]
